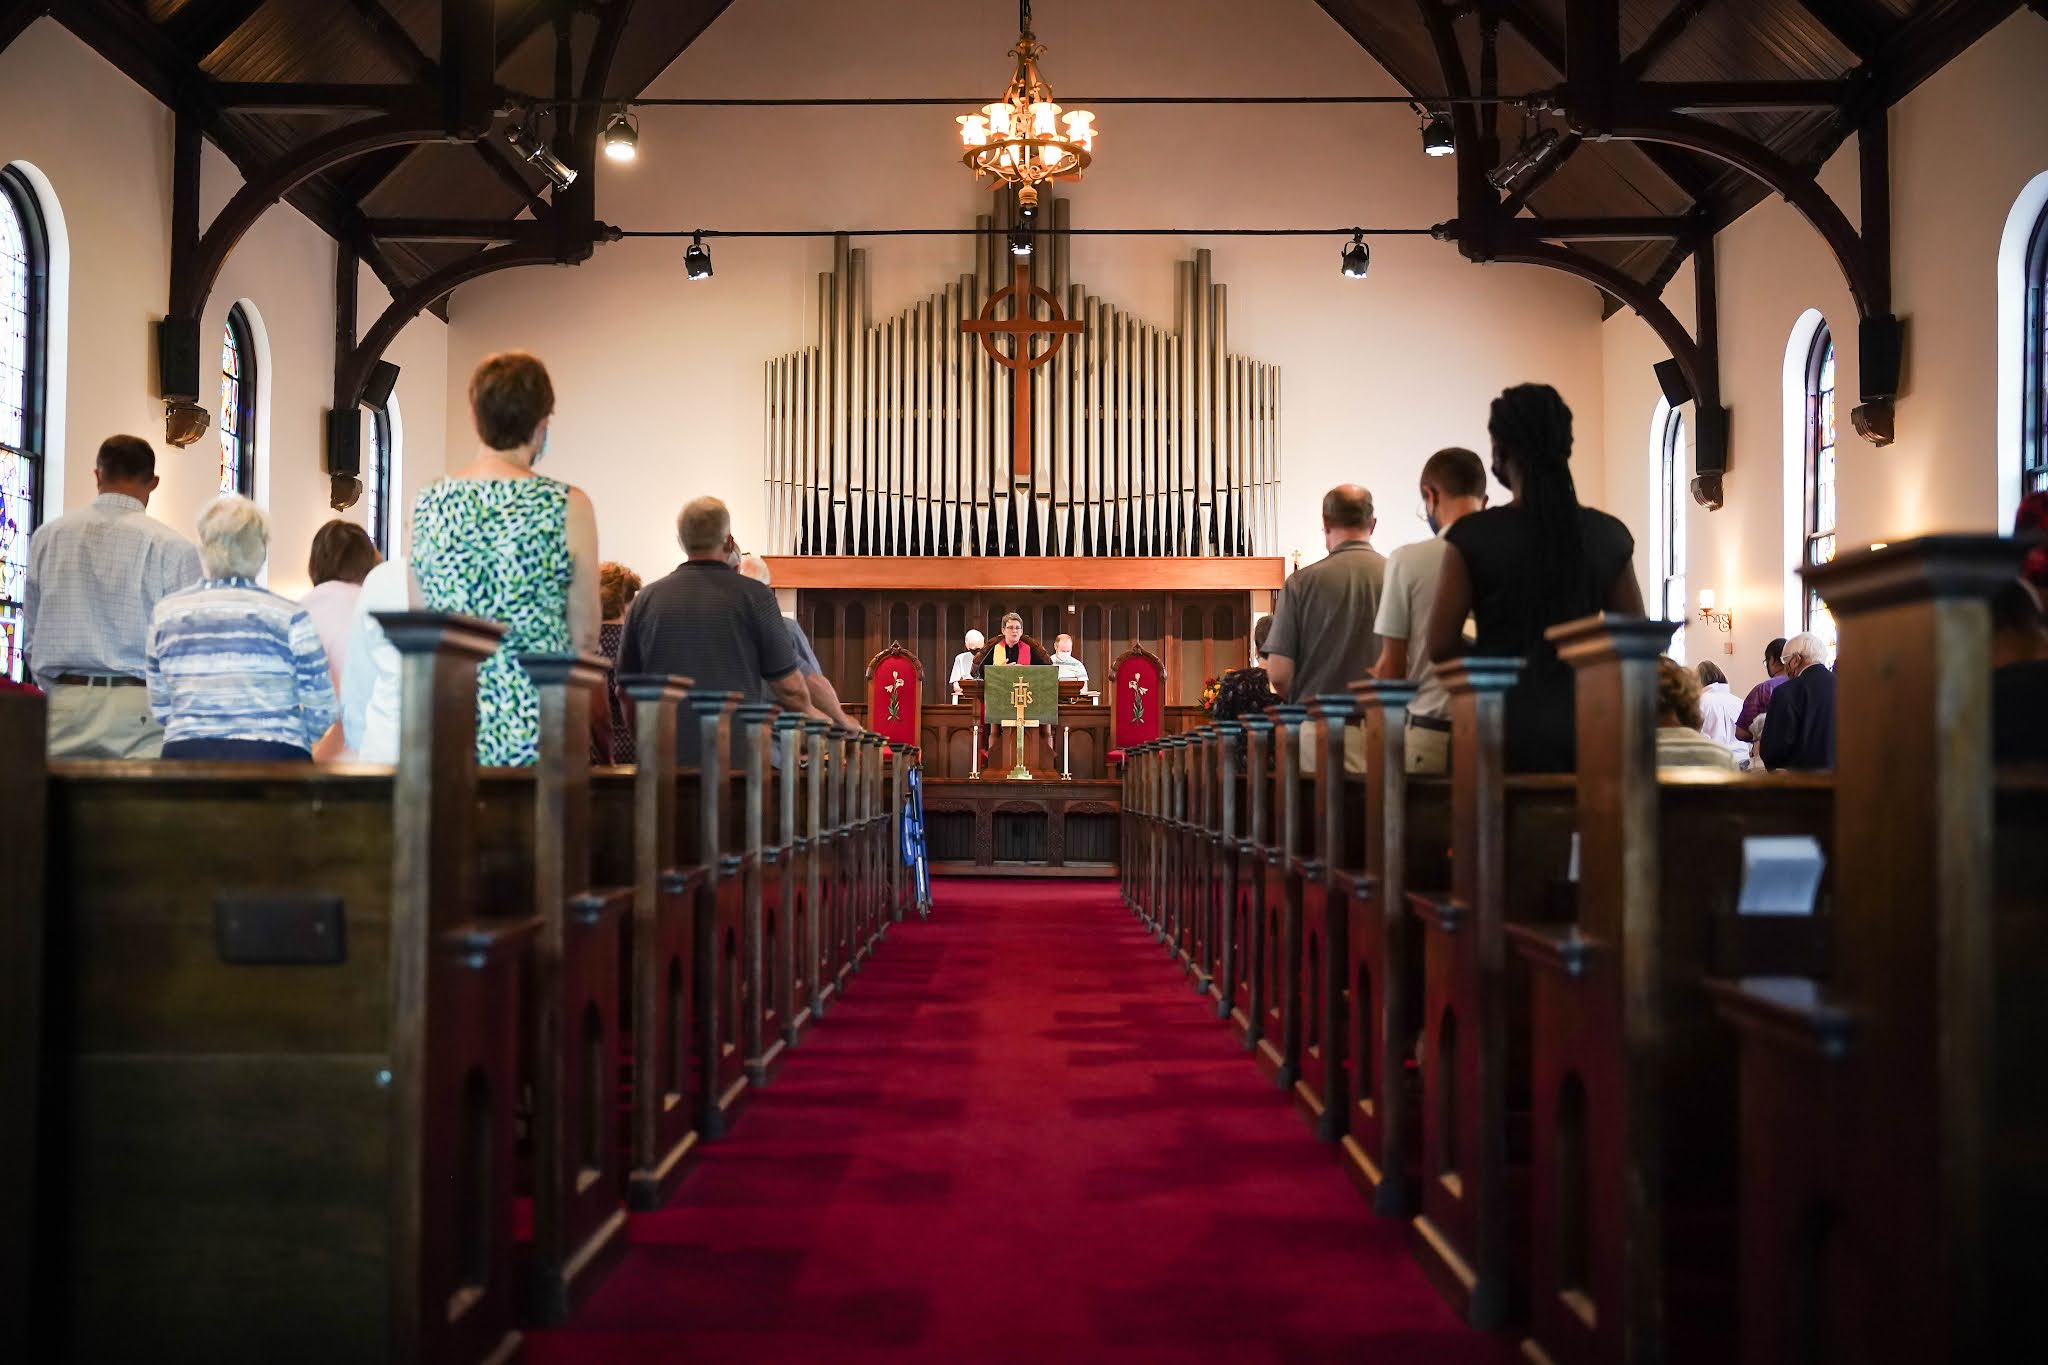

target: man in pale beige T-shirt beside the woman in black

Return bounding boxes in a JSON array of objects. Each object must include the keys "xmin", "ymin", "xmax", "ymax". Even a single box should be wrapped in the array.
[{"xmin": 1372, "ymin": 446, "xmax": 1487, "ymax": 776}]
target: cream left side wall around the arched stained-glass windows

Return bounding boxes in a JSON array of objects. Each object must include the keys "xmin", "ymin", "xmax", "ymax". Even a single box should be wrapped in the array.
[{"xmin": 0, "ymin": 18, "xmax": 446, "ymax": 593}]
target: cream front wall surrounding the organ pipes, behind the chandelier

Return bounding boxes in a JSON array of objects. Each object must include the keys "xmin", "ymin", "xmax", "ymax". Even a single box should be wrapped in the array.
[{"xmin": 446, "ymin": 0, "xmax": 1604, "ymax": 573}]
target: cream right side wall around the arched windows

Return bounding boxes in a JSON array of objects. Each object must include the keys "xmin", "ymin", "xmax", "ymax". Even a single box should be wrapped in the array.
[{"xmin": 1602, "ymin": 10, "xmax": 2048, "ymax": 688}]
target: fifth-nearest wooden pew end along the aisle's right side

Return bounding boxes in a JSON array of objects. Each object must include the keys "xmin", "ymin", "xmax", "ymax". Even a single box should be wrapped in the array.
[{"xmin": 1288, "ymin": 692, "xmax": 1366, "ymax": 1142}]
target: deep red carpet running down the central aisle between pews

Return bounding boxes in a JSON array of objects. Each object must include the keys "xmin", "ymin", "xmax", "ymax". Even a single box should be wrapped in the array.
[{"xmin": 528, "ymin": 882, "xmax": 1509, "ymax": 1365}]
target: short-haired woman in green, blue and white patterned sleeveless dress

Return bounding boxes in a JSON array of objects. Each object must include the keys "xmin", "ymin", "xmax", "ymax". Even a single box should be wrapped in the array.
[{"xmin": 412, "ymin": 350, "xmax": 600, "ymax": 767}]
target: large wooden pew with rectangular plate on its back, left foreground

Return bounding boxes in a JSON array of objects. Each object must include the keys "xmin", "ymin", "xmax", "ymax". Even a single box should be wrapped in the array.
[{"xmin": 39, "ymin": 614, "xmax": 541, "ymax": 1363}]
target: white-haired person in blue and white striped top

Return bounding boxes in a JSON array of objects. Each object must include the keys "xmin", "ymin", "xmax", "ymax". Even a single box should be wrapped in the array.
[{"xmin": 145, "ymin": 493, "xmax": 334, "ymax": 761}]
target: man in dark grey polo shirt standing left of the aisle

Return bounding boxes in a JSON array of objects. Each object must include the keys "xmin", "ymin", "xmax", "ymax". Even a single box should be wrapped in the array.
[{"xmin": 618, "ymin": 497, "xmax": 809, "ymax": 763}]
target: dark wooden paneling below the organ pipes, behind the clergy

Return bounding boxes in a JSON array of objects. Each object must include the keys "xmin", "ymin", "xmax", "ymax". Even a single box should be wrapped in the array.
[{"xmin": 784, "ymin": 585, "xmax": 1245, "ymax": 706}]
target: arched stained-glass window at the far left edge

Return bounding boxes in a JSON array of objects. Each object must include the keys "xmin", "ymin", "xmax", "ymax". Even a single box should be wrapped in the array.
[{"xmin": 0, "ymin": 166, "xmax": 49, "ymax": 681}]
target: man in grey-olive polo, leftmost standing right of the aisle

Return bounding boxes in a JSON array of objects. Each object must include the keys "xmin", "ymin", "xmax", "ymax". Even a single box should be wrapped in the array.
[{"xmin": 1266, "ymin": 483, "xmax": 1386, "ymax": 772}]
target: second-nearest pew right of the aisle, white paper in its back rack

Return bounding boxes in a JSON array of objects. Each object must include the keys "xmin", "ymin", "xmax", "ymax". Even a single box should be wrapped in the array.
[{"xmin": 1509, "ymin": 616, "xmax": 1833, "ymax": 1365}]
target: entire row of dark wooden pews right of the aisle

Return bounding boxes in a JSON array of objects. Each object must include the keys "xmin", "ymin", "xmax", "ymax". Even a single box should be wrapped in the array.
[{"xmin": 1122, "ymin": 536, "xmax": 2048, "ymax": 1363}]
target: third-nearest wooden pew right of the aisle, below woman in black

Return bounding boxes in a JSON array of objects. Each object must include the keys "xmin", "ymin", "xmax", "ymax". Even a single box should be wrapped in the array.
[{"xmin": 1409, "ymin": 657, "xmax": 1575, "ymax": 1330}]
